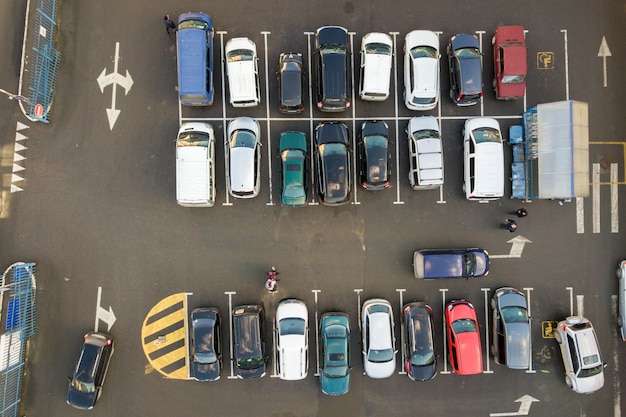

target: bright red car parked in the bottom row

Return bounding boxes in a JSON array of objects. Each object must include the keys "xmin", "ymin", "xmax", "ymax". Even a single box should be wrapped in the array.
[{"xmin": 446, "ymin": 300, "xmax": 483, "ymax": 375}]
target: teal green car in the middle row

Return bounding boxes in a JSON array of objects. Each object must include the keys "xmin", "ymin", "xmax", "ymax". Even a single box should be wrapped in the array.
[{"xmin": 279, "ymin": 132, "xmax": 308, "ymax": 207}]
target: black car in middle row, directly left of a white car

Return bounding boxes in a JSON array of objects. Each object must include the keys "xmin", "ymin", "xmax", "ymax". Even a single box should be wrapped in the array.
[{"xmin": 359, "ymin": 121, "xmax": 390, "ymax": 190}]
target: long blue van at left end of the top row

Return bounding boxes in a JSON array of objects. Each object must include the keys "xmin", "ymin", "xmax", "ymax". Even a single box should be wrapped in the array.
[{"xmin": 176, "ymin": 12, "xmax": 213, "ymax": 106}]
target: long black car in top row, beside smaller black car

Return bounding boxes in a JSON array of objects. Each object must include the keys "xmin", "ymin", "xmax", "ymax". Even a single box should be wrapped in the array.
[{"xmin": 315, "ymin": 26, "xmax": 352, "ymax": 112}]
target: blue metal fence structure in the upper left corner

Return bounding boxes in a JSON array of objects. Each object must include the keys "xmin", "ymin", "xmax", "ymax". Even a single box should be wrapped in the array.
[{"xmin": 25, "ymin": 0, "xmax": 61, "ymax": 123}]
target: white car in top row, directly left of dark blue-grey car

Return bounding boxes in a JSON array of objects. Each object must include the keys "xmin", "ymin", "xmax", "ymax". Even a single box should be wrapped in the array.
[{"xmin": 404, "ymin": 30, "xmax": 441, "ymax": 110}]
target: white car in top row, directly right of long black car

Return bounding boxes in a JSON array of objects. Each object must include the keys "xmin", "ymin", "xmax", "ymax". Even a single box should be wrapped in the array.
[{"xmin": 359, "ymin": 32, "xmax": 393, "ymax": 101}]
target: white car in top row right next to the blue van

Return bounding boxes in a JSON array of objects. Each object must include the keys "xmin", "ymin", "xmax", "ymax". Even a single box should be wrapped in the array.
[{"xmin": 225, "ymin": 38, "xmax": 261, "ymax": 107}]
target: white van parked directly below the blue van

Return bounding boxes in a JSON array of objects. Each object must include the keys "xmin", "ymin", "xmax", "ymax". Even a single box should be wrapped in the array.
[{"xmin": 176, "ymin": 122, "xmax": 215, "ymax": 207}]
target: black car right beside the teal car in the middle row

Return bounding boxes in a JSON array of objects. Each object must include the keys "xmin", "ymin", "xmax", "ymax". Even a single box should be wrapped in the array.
[{"xmin": 315, "ymin": 122, "xmax": 352, "ymax": 206}]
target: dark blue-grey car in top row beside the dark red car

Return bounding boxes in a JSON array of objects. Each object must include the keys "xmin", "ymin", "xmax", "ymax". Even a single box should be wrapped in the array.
[{"xmin": 447, "ymin": 33, "xmax": 483, "ymax": 106}]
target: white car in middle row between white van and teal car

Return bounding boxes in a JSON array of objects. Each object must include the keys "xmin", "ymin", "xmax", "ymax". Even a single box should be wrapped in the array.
[{"xmin": 227, "ymin": 117, "xmax": 261, "ymax": 198}]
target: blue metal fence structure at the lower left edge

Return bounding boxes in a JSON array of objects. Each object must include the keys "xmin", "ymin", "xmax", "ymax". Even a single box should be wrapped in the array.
[{"xmin": 0, "ymin": 262, "xmax": 36, "ymax": 417}]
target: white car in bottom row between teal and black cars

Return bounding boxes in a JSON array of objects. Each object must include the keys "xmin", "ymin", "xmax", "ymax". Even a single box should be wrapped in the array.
[{"xmin": 361, "ymin": 298, "xmax": 397, "ymax": 378}]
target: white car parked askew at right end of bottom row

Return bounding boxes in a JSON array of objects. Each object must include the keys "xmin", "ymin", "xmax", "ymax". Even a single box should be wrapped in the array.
[{"xmin": 554, "ymin": 316, "xmax": 606, "ymax": 394}]
